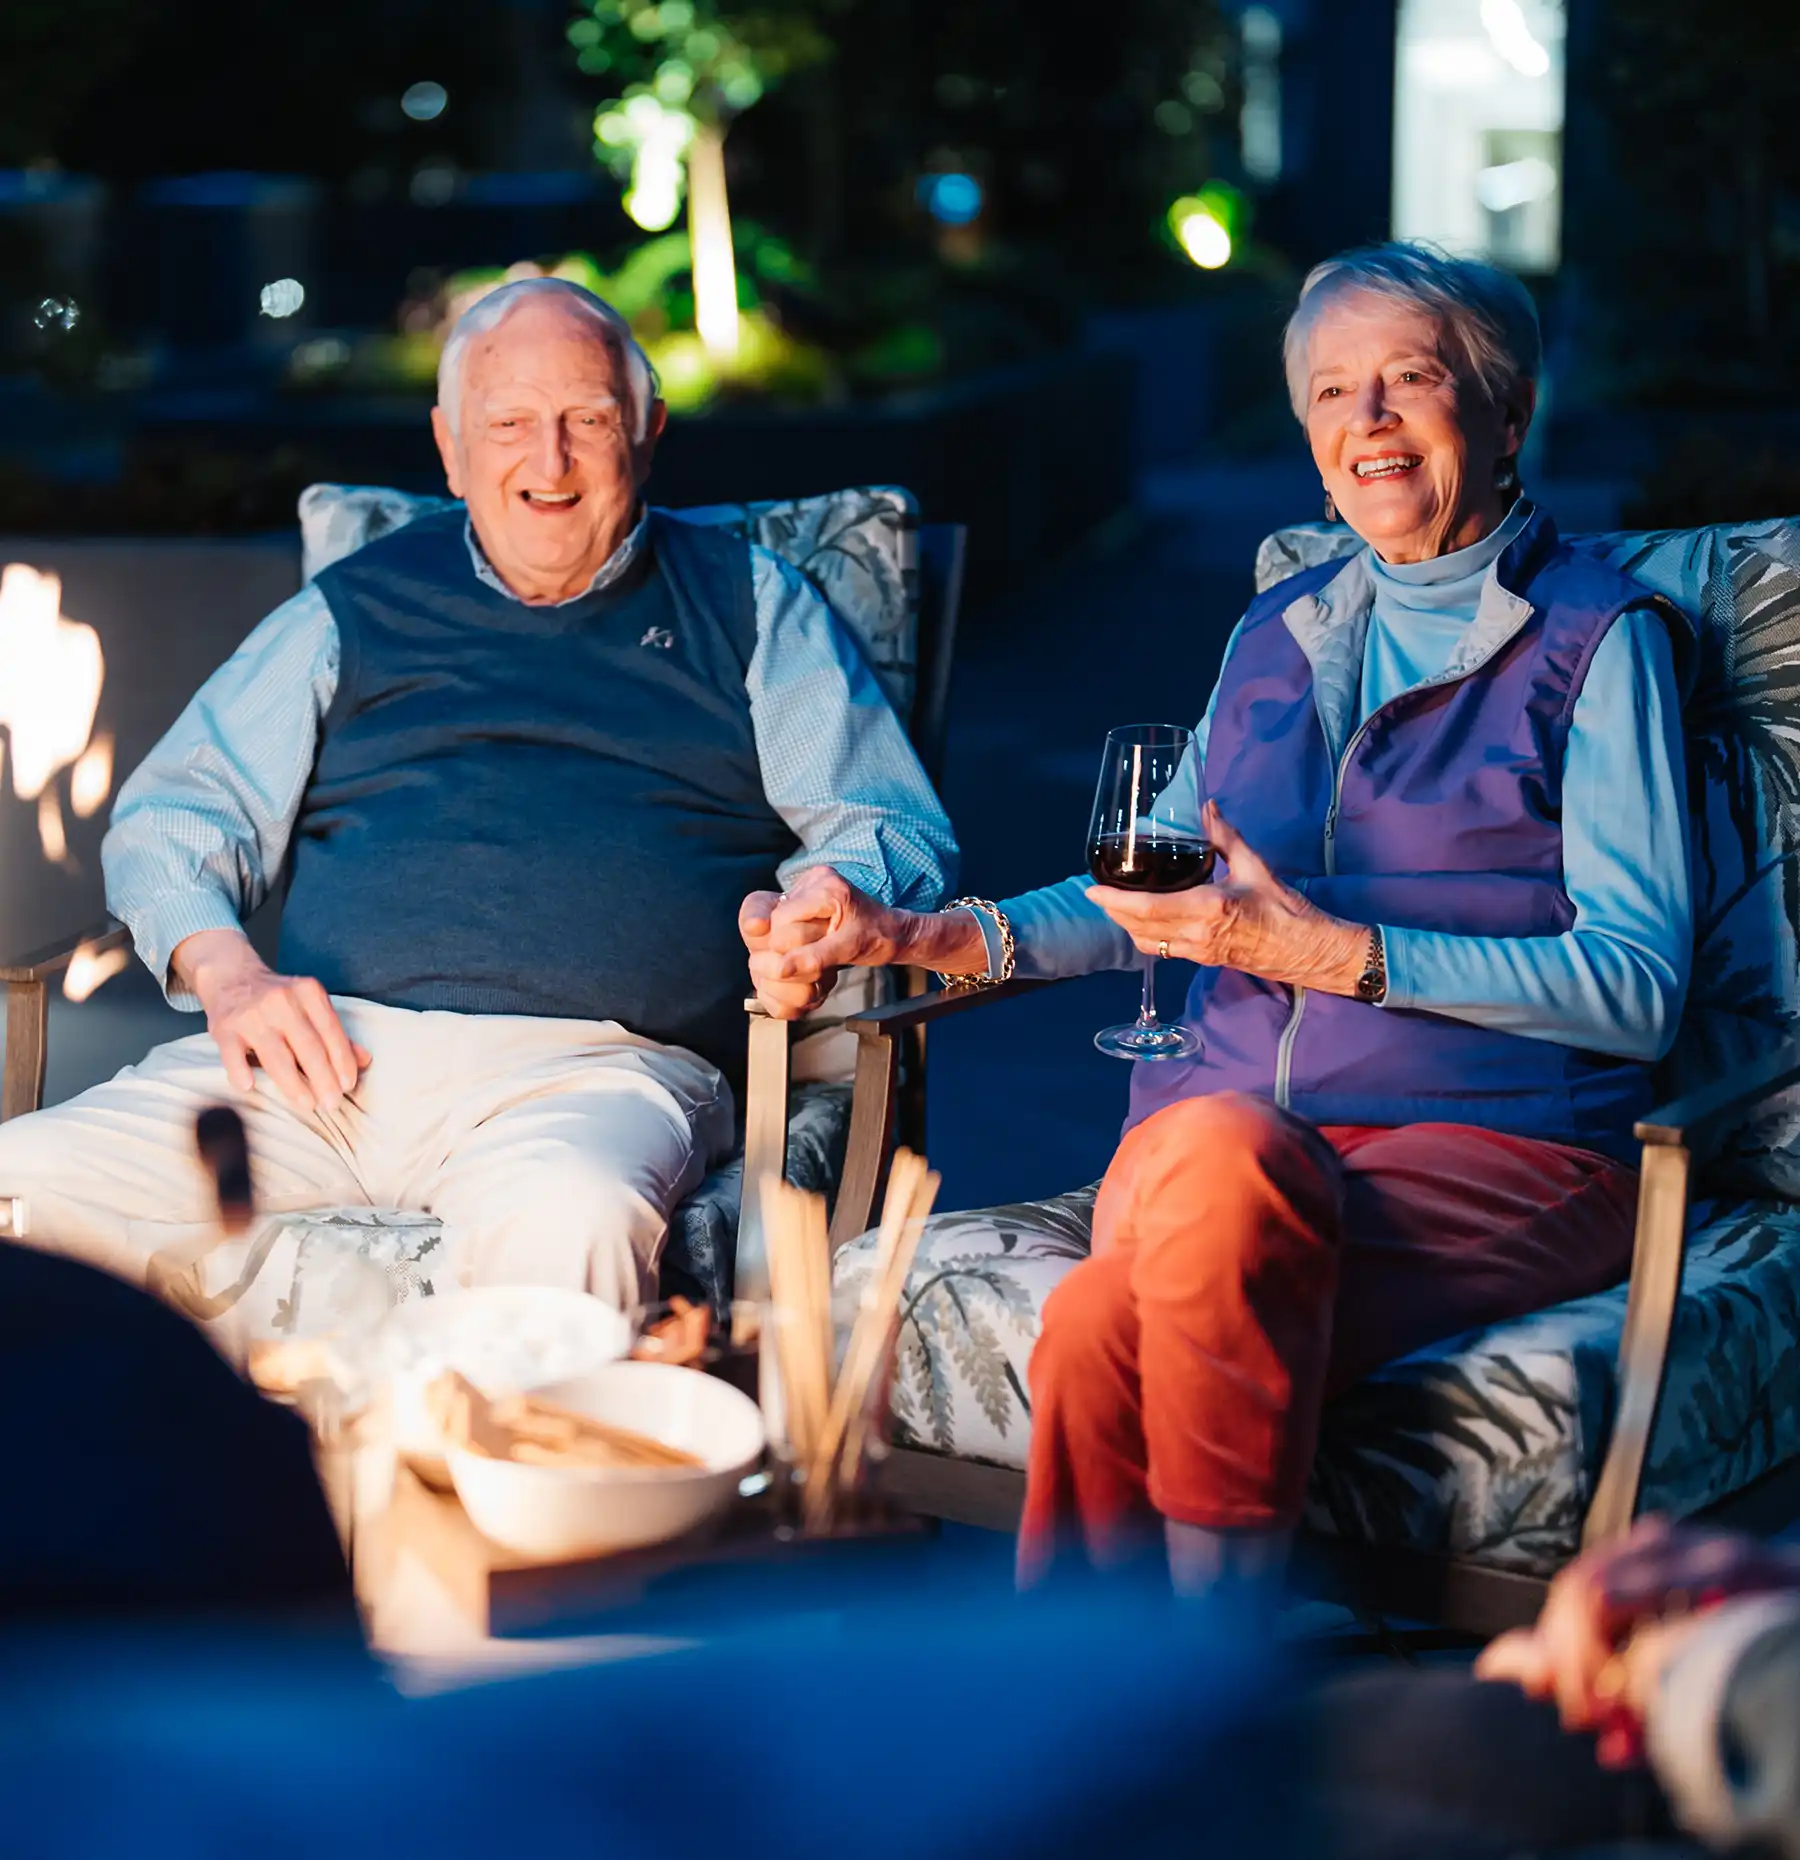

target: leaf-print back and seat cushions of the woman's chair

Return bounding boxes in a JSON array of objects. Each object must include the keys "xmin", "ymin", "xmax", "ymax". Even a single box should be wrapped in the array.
[{"xmin": 837, "ymin": 521, "xmax": 1800, "ymax": 1574}]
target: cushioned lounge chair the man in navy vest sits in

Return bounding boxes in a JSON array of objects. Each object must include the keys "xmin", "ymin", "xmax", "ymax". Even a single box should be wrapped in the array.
[{"xmin": 0, "ymin": 485, "xmax": 965, "ymax": 1309}]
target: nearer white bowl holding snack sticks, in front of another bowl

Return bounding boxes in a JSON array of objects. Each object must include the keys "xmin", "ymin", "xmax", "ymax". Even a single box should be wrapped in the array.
[{"xmin": 448, "ymin": 1363, "xmax": 762, "ymax": 1562}]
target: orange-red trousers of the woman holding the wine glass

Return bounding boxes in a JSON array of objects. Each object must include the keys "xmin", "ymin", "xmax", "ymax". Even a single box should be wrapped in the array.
[{"xmin": 1019, "ymin": 1092, "xmax": 1636, "ymax": 1583}]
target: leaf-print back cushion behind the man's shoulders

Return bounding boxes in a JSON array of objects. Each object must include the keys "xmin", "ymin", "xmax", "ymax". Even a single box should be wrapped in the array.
[{"xmin": 299, "ymin": 484, "xmax": 919, "ymax": 1081}]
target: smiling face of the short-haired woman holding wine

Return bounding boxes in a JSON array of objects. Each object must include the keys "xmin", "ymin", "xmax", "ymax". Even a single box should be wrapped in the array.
[{"xmin": 1305, "ymin": 290, "xmax": 1530, "ymax": 562}]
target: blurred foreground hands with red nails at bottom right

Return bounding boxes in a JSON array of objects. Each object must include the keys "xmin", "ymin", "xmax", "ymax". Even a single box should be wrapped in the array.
[{"xmin": 1475, "ymin": 1518, "xmax": 1800, "ymax": 1769}]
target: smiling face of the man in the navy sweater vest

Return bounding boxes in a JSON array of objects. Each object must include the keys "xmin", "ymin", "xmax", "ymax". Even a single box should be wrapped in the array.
[{"xmin": 431, "ymin": 296, "xmax": 664, "ymax": 603}]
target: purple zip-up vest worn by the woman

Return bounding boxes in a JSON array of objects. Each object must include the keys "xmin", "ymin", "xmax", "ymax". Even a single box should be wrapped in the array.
[{"xmin": 1127, "ymin": 515, "xmax": 1674, "ymax": 1159}]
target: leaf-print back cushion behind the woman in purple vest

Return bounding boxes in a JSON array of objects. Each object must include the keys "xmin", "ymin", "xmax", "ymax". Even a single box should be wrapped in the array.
[{"xmin": 1255, "ymin": 519, "xmax": 1800, "ymax": 1200}]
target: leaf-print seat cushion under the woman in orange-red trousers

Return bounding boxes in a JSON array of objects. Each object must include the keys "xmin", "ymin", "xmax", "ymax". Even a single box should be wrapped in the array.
[{"xmin": 837, "ymin": 1187, "xmax": 1800, "ymax": 1575}]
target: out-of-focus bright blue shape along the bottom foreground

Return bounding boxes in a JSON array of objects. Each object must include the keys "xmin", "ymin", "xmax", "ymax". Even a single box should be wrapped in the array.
[{"xmin": 0, "ymin": 1572, "xmax": 1294, "ymax": 1860}]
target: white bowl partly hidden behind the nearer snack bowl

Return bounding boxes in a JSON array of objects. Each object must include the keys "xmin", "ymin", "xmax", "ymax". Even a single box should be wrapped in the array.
[{"xmin": 376, "ymin": 1285, "xmax": 630, "ymax": 1486}]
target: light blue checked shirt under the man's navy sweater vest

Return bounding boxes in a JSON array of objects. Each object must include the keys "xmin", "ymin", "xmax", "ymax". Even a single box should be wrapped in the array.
[{"xmin": 100, "ymin": 517, "xmax": 958, "ymax": 1010}]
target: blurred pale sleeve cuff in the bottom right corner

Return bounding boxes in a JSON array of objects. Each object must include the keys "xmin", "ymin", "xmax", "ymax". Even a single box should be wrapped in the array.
[{"xmin": 1644, "ymin": 1594, "xmax": 1800, "ymax": 1841}]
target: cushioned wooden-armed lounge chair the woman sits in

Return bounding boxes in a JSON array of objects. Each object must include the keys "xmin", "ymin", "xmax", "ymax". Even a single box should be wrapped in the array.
[{"xmin": 792, "ymin": 521, "xmax": 1800, "ymax": 1633}]
